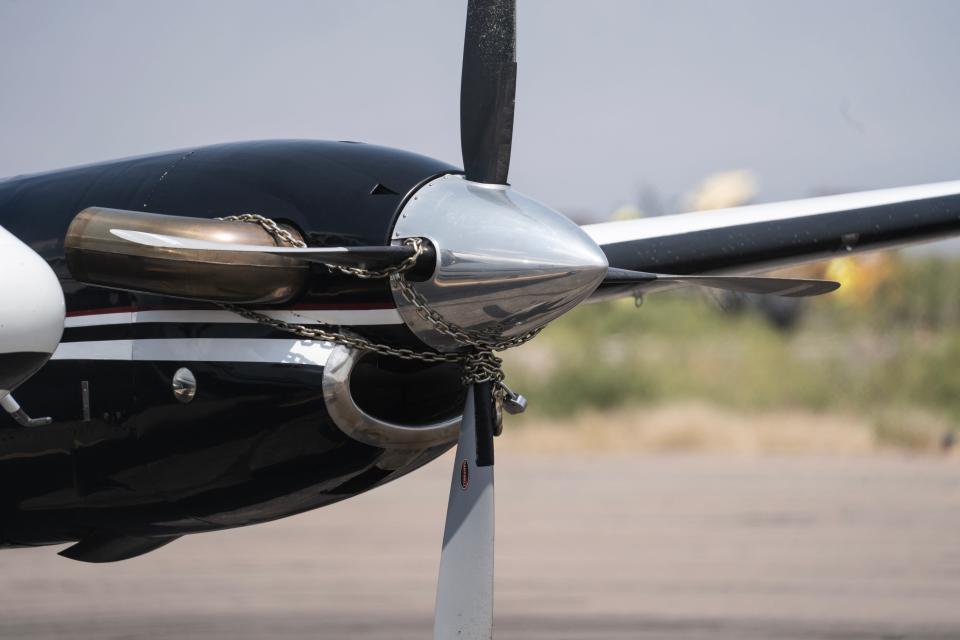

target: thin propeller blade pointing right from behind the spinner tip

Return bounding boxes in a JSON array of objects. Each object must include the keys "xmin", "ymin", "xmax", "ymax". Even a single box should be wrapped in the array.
[{"xmin": 599, "ymin": 268, "xmax": 840, "ymax": 298}]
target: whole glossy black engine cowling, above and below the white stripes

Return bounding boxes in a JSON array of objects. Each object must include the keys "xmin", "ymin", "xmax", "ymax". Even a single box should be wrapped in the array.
[{"xmin": 0, "ymin": 141, "xmax": 457, "ymax": 549}]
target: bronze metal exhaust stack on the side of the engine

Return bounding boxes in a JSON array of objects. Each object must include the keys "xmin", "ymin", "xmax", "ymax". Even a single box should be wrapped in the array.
[{"xmin": 64, "ymin": 207, "xmax": 310, "ymax": 304}]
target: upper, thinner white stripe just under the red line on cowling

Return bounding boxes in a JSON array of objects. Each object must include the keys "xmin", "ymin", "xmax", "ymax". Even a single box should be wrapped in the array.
[{"xmin": 66, "ymin": 309, "xmax": 403, "ymax": 329}]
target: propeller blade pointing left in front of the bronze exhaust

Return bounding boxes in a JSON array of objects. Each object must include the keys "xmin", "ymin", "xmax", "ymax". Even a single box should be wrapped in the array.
[{"xmin": 110, "ymin": 229, "xmax": 414, "ymax": 268}]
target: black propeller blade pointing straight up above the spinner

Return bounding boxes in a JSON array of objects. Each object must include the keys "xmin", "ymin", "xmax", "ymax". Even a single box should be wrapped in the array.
[{"xmin": 460, "ymin": 0, "xmax": 517, "ymax": 184}]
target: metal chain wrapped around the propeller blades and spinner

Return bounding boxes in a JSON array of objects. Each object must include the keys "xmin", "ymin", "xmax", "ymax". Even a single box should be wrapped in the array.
[{"xmin": 217, "ymin": 213, "xmax": 541, "ymax": 424}]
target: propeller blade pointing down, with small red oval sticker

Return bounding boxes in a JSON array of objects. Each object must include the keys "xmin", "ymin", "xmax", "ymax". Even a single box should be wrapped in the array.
[{"xmin": 433, "ymin": 383, "xmax": 494, "ymax": 640}]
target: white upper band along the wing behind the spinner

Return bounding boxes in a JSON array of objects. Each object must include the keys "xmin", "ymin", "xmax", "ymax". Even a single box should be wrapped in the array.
[{"xmin": 582, "ymin": 180, "xmax": 960, "ymax": 250}]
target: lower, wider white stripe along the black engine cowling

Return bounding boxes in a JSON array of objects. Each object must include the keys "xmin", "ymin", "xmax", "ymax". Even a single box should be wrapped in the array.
[{"xmin": 52, "ymin": 338, "xmax": 335, "ymax": 366}]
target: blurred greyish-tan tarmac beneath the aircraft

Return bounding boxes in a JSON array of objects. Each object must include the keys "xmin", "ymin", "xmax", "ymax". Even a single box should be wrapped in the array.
[{"xmin": 0, "ymin": 454, "xmax": 960, "ymax": 640}]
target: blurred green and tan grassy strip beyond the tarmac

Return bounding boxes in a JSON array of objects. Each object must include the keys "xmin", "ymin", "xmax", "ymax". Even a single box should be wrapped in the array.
[{"xmin": 503, "ymin": 260, "xmax": 960, "ymax": 455}]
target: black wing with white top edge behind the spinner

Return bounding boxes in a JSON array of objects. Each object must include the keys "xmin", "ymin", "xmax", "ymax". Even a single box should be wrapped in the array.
[{"xmin": 583, "ymin": 181, "xmax": 960, "ymax": 299}]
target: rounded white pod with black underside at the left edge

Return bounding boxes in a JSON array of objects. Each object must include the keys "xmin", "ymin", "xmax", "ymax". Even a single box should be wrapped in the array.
[{"xmin": 0, "ymin": 227, "xmax": 64, "ymax": 398}]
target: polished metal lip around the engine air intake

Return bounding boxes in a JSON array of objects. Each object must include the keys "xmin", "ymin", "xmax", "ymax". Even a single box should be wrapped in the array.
[{"xmin": 323, "ymin": 345, "xmax": 461, "ymax": 449}]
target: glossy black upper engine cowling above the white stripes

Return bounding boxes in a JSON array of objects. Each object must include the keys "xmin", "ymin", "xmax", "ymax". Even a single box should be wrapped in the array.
[{"xmin": 0, "ymin": 140, "xmax": 457, "ymax": 308}]
